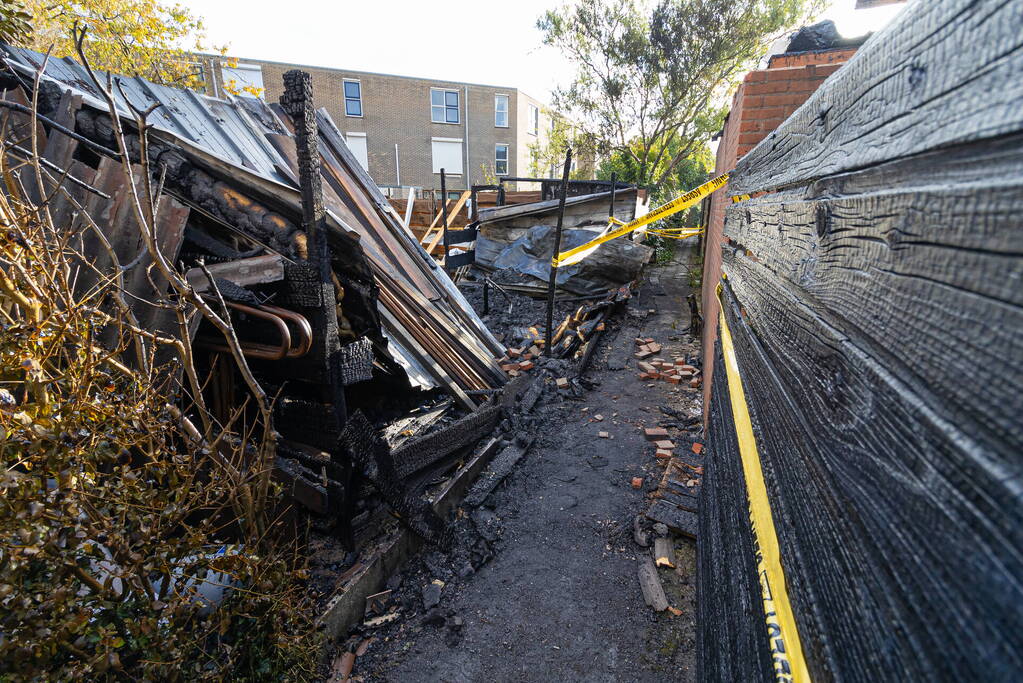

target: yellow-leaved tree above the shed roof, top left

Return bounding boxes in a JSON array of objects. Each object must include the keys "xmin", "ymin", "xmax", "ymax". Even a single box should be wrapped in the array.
[{"xmin": 18, "ymin": 0, "xmax": 223, "ymax": 89}]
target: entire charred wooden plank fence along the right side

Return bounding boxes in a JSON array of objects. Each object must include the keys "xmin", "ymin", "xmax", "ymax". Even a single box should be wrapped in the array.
[{"xmin": 699, "ymin": 0, "xmax": 1023, "ymax": 681}]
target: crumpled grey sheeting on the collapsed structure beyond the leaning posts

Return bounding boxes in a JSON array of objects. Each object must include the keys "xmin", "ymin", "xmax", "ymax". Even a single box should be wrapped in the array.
[{"xmin": 476, "ymin": 225, "xmax": 651, "ymax": 295}]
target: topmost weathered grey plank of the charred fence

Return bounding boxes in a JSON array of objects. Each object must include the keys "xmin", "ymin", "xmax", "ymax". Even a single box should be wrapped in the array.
[{"xmin": 728, "ymin": 0, "xmax": 1023, "ymax": 194}]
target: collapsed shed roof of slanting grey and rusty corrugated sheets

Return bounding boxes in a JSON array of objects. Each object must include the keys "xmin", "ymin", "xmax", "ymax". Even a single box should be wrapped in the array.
[{"xmin": 4, "ymin": 46, "xmax": 504, "ymax": 407}]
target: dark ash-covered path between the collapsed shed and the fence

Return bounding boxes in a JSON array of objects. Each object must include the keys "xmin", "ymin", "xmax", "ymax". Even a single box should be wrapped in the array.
[{"xmin": 335, "ymin": 249, "xmax": 702, "ymax": 682}]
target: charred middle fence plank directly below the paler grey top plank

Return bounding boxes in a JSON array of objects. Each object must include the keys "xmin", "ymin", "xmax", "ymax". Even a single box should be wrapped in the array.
[{"xmin": 723, "ymin": 131, "xmax": 1023, "ymax": 458}]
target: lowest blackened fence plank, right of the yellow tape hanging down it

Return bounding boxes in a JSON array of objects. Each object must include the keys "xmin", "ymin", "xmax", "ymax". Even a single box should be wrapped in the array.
[{"xmin": 725, "ymin": 269, "xmax": 1023, "ymax": 680}]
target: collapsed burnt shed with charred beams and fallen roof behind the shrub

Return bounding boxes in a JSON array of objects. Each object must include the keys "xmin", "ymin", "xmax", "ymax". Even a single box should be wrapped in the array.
[{"xmin": 2, "ymin": 47, "xmax": 506, "ymax": 550}]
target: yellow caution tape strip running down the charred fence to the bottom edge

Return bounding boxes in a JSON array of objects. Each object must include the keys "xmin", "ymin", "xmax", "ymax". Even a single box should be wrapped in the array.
[{"xmin": 717, "ymin": 285, "xmax": 810, "ymax": 683}]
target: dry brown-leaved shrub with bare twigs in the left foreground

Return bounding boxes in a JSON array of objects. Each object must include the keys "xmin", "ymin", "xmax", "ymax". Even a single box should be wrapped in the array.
[{"xmin": 0, "ymin": 93, "xmax": 317, "ymax": 680}]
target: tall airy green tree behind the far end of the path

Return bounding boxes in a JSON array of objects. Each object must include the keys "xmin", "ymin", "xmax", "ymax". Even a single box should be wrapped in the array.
[{"xmin": 537, "ymin": 0, "xmax": 821, "ymax": 191}]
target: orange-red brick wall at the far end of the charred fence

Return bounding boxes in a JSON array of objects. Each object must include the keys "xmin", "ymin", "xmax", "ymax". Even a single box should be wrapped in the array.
[{"xmin": 703, "ymin": 48, "xmax": 856, "ymax": 405}]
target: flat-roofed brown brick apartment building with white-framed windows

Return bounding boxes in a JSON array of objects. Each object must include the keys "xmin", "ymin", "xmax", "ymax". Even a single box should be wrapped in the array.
[{"xmin": 195, "ymin": 56, "xmax": 551, "ymax": 196}]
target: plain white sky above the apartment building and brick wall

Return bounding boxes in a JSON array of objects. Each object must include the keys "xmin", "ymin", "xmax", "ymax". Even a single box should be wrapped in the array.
[{"xmin": 177, "ymin": 0, "xmax": 900, "ymax": 101}]
